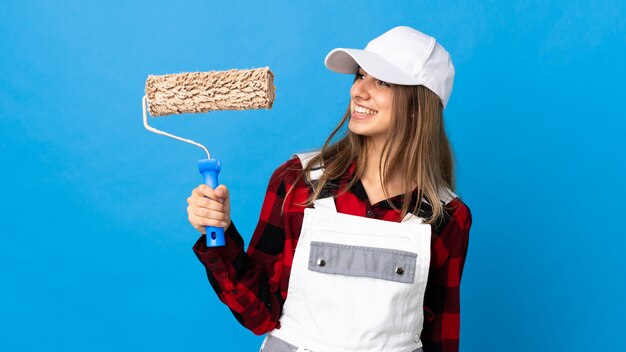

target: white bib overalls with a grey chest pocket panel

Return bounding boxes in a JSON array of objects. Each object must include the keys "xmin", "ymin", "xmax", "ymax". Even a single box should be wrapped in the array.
[{"xmin": 261, "ymin": 153, "xmax": 444, "ymax": 352}]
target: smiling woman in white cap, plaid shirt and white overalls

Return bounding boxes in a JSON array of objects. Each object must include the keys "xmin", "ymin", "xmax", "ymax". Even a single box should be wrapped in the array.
[{"xmin": 187, "ymin": 27, "xmax": 471, "ymax": 352}]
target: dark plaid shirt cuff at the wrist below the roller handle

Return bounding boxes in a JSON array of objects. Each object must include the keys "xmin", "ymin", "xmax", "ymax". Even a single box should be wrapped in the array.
[{"xmin": 193, "ymin": 221, "xmax": 243, "ymax": 271}]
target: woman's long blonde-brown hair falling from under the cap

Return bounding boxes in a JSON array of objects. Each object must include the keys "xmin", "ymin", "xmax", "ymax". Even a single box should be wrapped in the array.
[{"xmin": 283, "ymin": 73, "xmax": 455, "ymax": 224}]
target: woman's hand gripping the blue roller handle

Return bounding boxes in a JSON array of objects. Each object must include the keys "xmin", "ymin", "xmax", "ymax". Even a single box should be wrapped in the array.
[{"xmin": 187, "ymin": 184, "xmax": 231, "ymax": 235}]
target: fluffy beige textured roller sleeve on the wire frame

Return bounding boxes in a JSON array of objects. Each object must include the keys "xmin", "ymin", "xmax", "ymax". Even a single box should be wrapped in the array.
[{"xmin": 146, "ymin": 67, "xmax": 276, "ymax": 117}]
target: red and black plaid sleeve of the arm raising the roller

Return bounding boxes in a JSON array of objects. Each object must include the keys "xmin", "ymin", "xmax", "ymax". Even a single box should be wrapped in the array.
[{"xmin": 193, "ymin": 158, "xmax": 308, "ymax": 335}]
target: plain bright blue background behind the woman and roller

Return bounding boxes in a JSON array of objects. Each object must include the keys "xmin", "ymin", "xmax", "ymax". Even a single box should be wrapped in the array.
[{"xmin": 0, "ymin": 0, "xmax": 626, "ymax": 351}]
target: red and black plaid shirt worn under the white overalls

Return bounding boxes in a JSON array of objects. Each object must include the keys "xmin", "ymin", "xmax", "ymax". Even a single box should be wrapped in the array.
[{"xmin": 193, "ymin": 158, "xmax": 472, "ymax": 352}]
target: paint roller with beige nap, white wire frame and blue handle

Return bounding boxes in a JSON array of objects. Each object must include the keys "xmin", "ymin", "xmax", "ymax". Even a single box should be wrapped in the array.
[{"xmin": 142, "ymin": 67, "xmax": 276, "ymax": 247}]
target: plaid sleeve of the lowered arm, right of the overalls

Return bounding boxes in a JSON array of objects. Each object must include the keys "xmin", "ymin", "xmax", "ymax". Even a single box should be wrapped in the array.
[{"xmin": 421, "ymin": 198, "xmax": 472, "ymax": 352}]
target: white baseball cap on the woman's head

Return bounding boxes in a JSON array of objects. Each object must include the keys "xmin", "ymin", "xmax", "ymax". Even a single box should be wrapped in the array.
[{"xmin": 324, "ymin": 26, "xmax": 454, "ymax": 107}]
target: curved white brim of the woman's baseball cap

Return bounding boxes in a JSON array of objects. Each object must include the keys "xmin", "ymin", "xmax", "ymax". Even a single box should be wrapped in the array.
[{"xmin": 324, "ymin": 48, "xmax": 421, "ymax": 85}]
